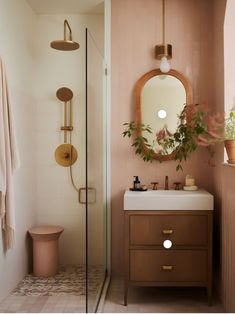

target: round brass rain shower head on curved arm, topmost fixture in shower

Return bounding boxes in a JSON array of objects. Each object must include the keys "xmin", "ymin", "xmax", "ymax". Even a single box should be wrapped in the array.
[{"xmin": 50, "ymin": 20, "xmax": 80, "ymax": 51}]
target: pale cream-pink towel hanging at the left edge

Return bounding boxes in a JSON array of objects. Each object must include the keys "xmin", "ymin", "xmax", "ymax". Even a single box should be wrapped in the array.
[{"xmin": 0, "ymin": 57, "xmax": 20, "ymax": 250}]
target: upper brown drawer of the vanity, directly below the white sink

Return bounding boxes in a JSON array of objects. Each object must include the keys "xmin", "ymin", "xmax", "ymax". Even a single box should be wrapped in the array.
[{"xmin": 129, "ymin": 214, "xmax": 208, "ymax": 246}]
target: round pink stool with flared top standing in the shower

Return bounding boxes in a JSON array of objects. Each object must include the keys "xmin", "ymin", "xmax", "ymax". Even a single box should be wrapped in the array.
[{"xmin": 28, "ymin": 226, "xmax": 64, "ymax": 277}]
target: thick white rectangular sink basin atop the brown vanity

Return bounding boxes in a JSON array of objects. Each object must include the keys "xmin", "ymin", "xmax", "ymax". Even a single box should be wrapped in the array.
[{"xmin": 124, "ymin": 190, "xmax": 214, "ymax": 210}]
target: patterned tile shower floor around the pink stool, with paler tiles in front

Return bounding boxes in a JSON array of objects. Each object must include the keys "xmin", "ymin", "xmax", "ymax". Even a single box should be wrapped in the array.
[{"xmin": 0, "ymin": 265, "xmax": 103, "ymax": 313}]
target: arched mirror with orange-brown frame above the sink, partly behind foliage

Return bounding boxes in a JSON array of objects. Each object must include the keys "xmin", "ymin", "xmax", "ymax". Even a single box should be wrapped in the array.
[{"xmin": 135, "ymin": 69, "xmax": 192, "ymax": 161}]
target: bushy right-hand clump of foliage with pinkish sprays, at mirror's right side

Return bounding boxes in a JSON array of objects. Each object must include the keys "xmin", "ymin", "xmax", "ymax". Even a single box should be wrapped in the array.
[{"xmin": 157, "ymin": 105, "xmax": 223, "ymax": 171}]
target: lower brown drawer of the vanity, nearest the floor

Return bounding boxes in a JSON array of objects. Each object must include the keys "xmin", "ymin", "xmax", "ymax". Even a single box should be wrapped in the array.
[{"xmin": 130, "ymin": 250, "xmax": 207, "ymax": 283}]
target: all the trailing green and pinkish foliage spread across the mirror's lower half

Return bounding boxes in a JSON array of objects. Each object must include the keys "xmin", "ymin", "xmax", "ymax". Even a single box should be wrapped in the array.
[{"xmin": 123, "ymin": 105, "xmax": 224, "ymax": 171}]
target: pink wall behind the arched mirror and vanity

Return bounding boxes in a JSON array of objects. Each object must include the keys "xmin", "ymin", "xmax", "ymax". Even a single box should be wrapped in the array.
[{"xmin": 111, "ymin": 0, "xmax": 217, "ymax": 274}]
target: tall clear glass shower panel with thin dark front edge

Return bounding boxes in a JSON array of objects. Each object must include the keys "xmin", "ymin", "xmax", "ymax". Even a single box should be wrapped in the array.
[{"xmin": 86, "ymin": 30, "xmax": 106, "ymax": 312}]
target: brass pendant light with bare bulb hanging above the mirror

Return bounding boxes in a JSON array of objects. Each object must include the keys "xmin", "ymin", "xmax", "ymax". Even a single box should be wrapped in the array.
[{"xmin": 155, "ymin": 0, "xmax": 172, "ymax": 73}]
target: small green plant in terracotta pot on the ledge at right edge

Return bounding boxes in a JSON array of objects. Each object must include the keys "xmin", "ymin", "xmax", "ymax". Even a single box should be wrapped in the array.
[{"xmin": 224, "ymin": 111, "xmax": 235, "ymax": 164}]
